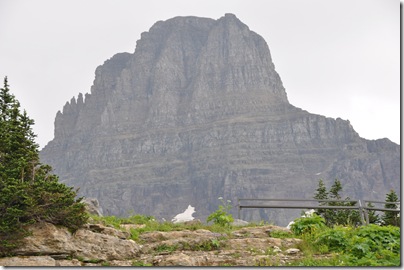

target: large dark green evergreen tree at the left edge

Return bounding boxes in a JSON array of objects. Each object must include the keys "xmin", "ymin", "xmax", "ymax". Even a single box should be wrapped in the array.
[{"xmin": 0, "ymin": 78, "xmax": 87, "ymax": 256}]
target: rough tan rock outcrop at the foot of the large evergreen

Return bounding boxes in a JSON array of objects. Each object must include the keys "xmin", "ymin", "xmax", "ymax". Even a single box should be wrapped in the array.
[{"xmin": 14, "ymin": 223, "xmax": 140, "ymax": 261}]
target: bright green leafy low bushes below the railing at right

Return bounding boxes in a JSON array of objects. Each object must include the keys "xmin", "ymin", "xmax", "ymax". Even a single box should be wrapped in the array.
[{"xmin": 291, "ymin": 205, "xmax": 401, "ymax": 266}]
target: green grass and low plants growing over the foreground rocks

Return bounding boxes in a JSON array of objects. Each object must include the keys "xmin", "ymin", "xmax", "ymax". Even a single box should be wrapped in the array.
[{"xmin": 91, "ymin": 215, "xmax": 401, "ymax": 266}]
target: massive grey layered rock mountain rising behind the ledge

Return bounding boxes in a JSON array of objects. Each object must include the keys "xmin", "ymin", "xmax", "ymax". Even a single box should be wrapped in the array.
[{"xmin": 40, "ymin": 14, "xmax": 400, "ymax": 225}]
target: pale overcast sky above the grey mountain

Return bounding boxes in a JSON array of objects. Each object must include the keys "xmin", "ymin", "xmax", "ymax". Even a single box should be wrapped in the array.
[{"xmin": 0, "ymin": 0, "xmax": 400, "ymax": 147}]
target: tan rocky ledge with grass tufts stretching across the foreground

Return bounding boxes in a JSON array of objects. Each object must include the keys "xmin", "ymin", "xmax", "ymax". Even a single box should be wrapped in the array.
[{"xmin": 0, "ymin": 222, "xmax": 324, "ymax": 266}]
